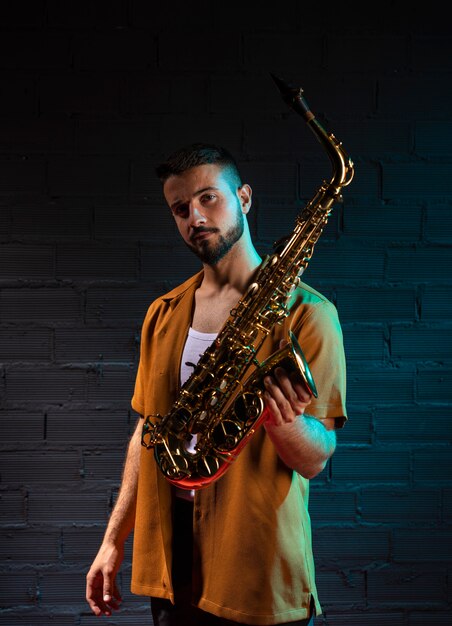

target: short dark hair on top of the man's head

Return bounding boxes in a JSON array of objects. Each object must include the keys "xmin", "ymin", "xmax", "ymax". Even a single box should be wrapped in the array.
[{"xmin": 155, "ymin": 143, "xmax": 242, "ymax": 187}]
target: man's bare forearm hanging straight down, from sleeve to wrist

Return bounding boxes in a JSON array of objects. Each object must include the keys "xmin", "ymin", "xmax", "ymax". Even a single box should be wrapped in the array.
[{"xmin": 104, "ymin": 420, "xmax": 142, "ymax": 544}]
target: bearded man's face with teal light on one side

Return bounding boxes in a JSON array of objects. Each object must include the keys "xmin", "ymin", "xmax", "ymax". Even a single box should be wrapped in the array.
[{"xmin": 163, "ymin": 165, "xmax": 248, "ymax": 265}]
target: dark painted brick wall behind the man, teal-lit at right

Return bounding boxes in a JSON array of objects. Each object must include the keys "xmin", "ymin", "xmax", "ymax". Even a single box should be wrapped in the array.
[{"xmin": 0, "ymin": 0, "xmax": 452, "ymax": 626}]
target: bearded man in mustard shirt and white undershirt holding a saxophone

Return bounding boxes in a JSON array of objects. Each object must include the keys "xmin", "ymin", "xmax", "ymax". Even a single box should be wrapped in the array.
[{"xmin": 86, "ymin": 144, "xmax": 346, "ymax": 626}]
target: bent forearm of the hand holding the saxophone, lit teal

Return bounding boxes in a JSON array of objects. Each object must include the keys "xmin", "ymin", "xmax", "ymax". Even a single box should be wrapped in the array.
[{"xmin": 265, "ymin": 414, "xmax": 336, "ymax": 478}]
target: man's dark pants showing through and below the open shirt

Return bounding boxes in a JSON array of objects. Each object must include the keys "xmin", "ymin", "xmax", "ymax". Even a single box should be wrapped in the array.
[{"xmin": 151, "ymin": 498, "xmax": 314, "ymax": 626}]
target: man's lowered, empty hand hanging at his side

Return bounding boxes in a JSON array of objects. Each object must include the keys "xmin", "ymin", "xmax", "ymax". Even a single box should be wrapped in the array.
[{"xmin": 86, "ymin": 543, "xmax": 124, "ymax": 617}]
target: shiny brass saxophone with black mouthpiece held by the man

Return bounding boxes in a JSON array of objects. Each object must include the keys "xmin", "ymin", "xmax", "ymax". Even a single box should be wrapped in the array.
[{"xmin": 141, "ymin": 75, "xmax": 354, "ymax": 489}]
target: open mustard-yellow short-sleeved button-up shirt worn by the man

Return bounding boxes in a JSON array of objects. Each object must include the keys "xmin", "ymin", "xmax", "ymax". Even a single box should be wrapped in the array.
[{"xmin": 131, "ymin": 272, "xmax": 346, "ymax": 625}]
